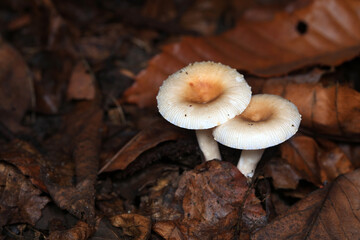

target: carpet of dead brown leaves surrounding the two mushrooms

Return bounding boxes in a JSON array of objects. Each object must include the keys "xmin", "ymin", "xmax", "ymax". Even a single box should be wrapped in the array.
[{"xmin": 0, "ymin": 0, "xmax": 360, "ymax": 239}]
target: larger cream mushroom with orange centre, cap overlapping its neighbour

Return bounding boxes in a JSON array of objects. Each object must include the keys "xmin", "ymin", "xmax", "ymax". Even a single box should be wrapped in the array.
[{"xmin": 156, "ymin": 61, "xmax": 251, "ymax": 161}]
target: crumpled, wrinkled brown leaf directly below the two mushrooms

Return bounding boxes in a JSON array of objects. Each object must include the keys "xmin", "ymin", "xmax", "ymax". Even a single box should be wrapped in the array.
[{"xmin": 153, "ymin": 161, "xmax": 266, "ymax": 239}]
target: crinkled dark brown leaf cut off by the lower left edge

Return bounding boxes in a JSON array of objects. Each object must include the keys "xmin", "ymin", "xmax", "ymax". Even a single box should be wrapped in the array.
[{"xmin": 0, "ymin": 163, "xmax": 49, "ymax": 228}]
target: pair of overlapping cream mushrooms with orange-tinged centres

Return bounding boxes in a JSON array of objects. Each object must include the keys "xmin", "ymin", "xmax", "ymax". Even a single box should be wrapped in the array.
[{"xmin": 156, "ymin": 61, "xmax": 301, "ymax": 178}]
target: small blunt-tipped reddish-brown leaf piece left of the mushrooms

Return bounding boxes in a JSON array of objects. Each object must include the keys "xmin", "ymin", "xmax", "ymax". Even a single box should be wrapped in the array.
[{"xmin": 67, "ymin": 62, "xmax": 95, "ymax": 100}]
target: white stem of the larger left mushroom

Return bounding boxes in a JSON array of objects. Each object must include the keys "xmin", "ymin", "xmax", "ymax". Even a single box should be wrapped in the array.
[{"xmin": 196, "ymin": 129, "xmax": 221, "ymax": 161}]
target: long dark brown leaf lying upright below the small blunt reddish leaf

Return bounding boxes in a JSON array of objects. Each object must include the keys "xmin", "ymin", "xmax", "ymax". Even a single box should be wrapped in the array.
[{"xmin": 42, "ymin": 102, "xmax": 102, "ymax": 225}]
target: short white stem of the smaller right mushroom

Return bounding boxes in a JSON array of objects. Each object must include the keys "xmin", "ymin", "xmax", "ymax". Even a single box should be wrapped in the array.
[{"xmin": 237, "ymin": 149, "xmax": 265, "ymax": 178}]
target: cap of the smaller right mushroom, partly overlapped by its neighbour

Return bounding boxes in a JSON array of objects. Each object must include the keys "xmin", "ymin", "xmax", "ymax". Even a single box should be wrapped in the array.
[{"xmin": 213, "ymin": 94, "xmax": 301, "ymax": 150}]
